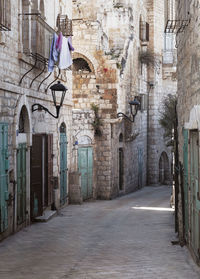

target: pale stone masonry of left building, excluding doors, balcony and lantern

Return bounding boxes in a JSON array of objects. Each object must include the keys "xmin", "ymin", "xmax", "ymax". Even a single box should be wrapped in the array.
[{"xmin": 0, "ymin": 1, "xmax": 72, "ymax": 239}]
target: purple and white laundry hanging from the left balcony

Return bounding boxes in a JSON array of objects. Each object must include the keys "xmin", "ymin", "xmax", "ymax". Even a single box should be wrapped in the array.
[{"xmin": 48, "ymin": 32, "xmax": 74, "ymax": 72}]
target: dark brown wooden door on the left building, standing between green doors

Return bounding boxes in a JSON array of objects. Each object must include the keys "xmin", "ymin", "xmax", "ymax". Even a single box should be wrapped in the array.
[{"xmin": 31, "ymin": 134, "xmax": 53, "ymax": 219}]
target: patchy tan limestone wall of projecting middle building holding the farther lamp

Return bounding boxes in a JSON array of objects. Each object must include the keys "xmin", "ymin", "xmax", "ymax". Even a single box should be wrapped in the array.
[{"xmin": 73, "ymin": 1, "xmax": 150, "ymax": 199}]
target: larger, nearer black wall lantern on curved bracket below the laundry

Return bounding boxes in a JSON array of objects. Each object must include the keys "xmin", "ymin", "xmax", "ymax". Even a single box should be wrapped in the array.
[{"xmin": 32, "ymin": 81, "xmax": 68, "ymax": 118}]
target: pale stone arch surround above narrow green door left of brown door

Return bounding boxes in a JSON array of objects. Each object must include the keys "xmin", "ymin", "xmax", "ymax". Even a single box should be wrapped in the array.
[{"xmin": 13, "ymin": 96, "xmax": 32, "ymax": 148}]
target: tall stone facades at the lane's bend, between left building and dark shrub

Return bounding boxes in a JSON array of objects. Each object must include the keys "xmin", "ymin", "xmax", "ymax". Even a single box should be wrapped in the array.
[{"xmin": 73, "ymin": 0, "xmax": 176, "ymax": 199}]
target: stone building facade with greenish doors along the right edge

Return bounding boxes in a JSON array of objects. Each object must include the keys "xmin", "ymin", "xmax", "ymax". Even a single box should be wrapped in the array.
[{"xmin": 175, "ymin": 0, "xmax": 200, "ymax": 263}]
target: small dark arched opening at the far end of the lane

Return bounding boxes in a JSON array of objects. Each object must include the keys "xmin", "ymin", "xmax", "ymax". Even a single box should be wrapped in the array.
[{"xmin": 159, "ymin": 151, "xmax": 170, "ymax": 184}]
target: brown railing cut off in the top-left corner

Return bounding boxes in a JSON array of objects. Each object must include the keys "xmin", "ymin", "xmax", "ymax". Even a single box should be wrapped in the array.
[{"xmin": 0, "ymin": 0, "xmax": 11, "ymax": 31}]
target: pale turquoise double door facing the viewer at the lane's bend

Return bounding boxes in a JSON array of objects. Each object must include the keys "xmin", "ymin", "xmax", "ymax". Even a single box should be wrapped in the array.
[{"xmin": 78, "ymin": 147, "xmax": 93, "ymax": 200}]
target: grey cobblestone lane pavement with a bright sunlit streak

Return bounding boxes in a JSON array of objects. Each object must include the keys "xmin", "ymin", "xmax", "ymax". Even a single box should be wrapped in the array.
[{"xmin": 0, "ymin": 186, "xmax": 200, "ymax": 279}]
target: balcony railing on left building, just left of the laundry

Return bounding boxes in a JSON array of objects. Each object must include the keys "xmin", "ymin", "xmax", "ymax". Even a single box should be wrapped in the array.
[{"xmin": 22, "ymin": 14, "xmax": 55, "ymax": 62}]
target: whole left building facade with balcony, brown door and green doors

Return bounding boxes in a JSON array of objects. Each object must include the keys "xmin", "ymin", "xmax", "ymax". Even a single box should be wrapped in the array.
[{"xmin": 0, "ymin": 0, "xmax": 72, "ymax": 240}]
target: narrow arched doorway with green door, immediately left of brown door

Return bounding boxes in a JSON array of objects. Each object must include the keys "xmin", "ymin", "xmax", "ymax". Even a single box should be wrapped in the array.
[{"xmin": 17, "ymin": 105, "xmax": 30, "ymax": 225}]
